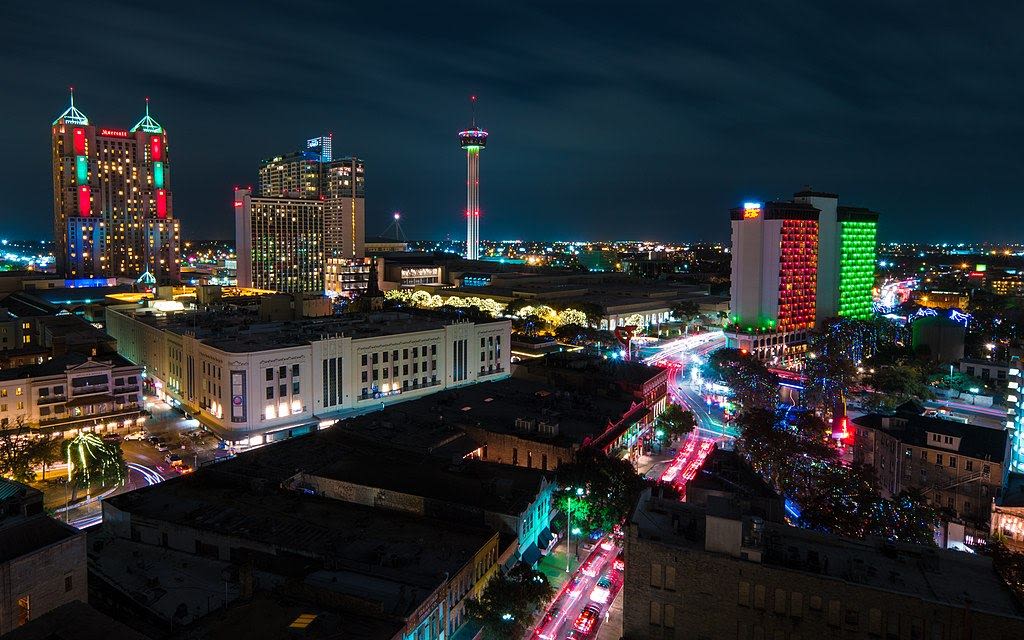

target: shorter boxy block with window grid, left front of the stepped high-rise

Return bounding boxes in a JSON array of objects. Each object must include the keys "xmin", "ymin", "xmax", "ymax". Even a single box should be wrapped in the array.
[{"xmin": 234, "ymin": 188, "xmax": 326, "ymax": 293}]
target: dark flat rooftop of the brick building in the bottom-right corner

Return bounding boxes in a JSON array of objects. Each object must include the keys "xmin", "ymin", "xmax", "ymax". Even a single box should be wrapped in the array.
[{"xmin": 632, "ymin": 495, "xmax": 1021, "ymax": 615}]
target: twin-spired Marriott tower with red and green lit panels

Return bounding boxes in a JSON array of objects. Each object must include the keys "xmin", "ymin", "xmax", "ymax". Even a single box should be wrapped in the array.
[{"xmin": 51, "ymin": 94, "xmax": 180, "ymax": 283}]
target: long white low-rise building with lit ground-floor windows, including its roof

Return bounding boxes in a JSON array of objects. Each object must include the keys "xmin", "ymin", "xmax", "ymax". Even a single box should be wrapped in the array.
[{"xmin": 106, "ymin": 306, "xmax": 511, "ymax": 444}]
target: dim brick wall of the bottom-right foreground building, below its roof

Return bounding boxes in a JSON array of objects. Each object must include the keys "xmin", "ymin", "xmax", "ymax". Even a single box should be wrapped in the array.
[{"xmin": 623, "ymin": 527, "xmax": 1024, "ymax": 640}]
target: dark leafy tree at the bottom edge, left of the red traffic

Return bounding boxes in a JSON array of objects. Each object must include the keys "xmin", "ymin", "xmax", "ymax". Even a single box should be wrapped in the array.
[{"xmin": 466, "ymin": 562, "xmax": 555, "ymax": 640}]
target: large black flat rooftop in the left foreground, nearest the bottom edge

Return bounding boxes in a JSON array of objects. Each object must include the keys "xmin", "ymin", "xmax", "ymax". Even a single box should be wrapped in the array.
[{"xmin": 104, "ymin": 465, "xmax": 495, "ymax": 617}]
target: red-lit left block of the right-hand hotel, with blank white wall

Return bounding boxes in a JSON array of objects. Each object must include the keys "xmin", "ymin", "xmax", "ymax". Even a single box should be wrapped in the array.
[{"xmin": 725, "ymin": 202, "xmax": 820, "ymax": 365}]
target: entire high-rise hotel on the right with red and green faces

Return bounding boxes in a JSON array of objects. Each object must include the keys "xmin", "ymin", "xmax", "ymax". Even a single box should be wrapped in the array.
[{"xmin": 726, "ymin": 189, "xmax": 879, "ymax": 365}]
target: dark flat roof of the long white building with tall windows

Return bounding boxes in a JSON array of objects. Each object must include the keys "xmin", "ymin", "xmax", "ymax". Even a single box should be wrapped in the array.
[{"xmin": 117, "ymin": 307, "xmax": 507, "ymax": 353}]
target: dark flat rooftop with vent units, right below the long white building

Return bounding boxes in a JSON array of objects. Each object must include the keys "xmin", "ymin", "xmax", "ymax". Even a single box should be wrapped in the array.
[{"xmin": 334, "ymin": 377, "xmax": 634, "ymax": 446}]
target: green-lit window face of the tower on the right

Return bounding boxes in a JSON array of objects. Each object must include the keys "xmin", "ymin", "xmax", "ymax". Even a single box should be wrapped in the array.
[{"xmin": 839, "ymin": 220, "xmax": 878, "ymax": 319}]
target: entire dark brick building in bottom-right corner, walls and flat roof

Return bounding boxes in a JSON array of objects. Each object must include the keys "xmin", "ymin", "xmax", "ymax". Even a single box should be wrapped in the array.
[{"xmin": 623, "ymin": 492, "xmax": 1024, "ymax": 640}]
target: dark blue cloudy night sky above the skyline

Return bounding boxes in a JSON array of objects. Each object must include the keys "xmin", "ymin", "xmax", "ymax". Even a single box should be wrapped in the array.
[{"xmin": 0, "ymin": 0, "xmax": 1024, "ymax": 241}]
